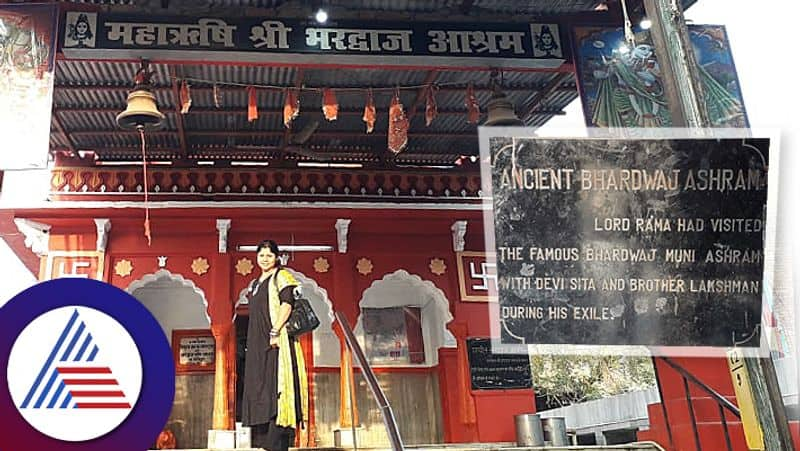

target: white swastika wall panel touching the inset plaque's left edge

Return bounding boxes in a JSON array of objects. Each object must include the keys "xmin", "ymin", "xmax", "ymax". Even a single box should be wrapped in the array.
[{"xmin": 456, "ymin": 252, "xmax": 497, "ymax": 302}]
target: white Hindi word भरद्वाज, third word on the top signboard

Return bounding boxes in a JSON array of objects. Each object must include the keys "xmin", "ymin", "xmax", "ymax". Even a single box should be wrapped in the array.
[{"xmin": 306, "ymin": 28, "xmax": 413, "ymax": 52}]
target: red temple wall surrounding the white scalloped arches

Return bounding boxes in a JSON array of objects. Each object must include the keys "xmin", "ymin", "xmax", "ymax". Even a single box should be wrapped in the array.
[{"xmin": 37, "ymin": 208, "xmax": 535, "ymax": 442}]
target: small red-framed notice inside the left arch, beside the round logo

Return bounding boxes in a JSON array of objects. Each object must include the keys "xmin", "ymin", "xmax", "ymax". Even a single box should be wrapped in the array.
[{"xmin": 172, "ymin": 329, "xmax": 216, "ymax": 374}]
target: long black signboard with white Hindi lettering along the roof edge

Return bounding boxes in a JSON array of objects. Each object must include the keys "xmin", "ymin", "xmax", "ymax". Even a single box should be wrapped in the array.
[{"xmin": 61, "ymin": 11, "xmax": 569, "ymax": 68}]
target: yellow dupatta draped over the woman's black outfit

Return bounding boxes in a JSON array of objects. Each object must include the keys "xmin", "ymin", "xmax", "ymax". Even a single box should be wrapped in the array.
[{"xmin": 269, "ymin": 269, "xmax": 308, "ymax": 427}]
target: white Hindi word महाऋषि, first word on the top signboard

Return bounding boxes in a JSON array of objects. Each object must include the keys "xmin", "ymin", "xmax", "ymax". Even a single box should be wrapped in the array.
[{"xmin": 106, "ymin": 19, "xmax": 236, "ymax": 47}]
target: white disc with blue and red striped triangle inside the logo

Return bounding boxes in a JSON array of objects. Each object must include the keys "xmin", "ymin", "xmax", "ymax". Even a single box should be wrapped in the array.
[{"xmin": 7, "ymin": 306, "xmax": 142, "ymax": 442}]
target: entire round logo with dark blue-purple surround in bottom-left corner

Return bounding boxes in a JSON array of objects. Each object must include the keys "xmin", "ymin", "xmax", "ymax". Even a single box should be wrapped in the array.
[{"xmin": 0, "ymin": 279, "xmax": 175, "ymax": 451}]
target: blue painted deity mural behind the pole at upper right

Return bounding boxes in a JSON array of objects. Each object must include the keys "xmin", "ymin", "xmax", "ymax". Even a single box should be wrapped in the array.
[{"xmin": 575, "ymin": 25, "xmax": 748, "ymax": 127}]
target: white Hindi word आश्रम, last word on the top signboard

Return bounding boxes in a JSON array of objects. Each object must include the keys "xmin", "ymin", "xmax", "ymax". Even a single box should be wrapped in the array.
[{"xmin": 428, "ymin": 30, "xmax": 525, "ymax": 54}]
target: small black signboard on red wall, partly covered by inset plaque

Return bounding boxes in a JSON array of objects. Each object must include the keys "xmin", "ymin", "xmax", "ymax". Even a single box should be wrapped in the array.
[{"xmin": 467, "ymin": 338, "xmax": 531, "ymax": 390}]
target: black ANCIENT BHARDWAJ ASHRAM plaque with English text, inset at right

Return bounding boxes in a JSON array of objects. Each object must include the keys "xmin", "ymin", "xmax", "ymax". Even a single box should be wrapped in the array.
[{"xmin": 484, "ymin": 137, "xmax": 770, "ymax": 347}]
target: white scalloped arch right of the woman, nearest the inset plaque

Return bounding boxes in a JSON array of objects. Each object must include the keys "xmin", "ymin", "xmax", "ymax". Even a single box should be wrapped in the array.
[{"xmin": 354, "ymin": 269, "xmax": 456, "ymax": 366}]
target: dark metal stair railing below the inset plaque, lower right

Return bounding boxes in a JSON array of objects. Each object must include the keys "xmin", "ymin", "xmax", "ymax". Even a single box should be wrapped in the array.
[{"xmin": 653, "ymin": 357, "xmax": 742, "ymax": 451}]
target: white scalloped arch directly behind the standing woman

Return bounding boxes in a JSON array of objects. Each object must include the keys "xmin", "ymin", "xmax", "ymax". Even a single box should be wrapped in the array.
[{"xmin": 233, "ymin": 268, "xmax": 340, "ymax": 367}]
